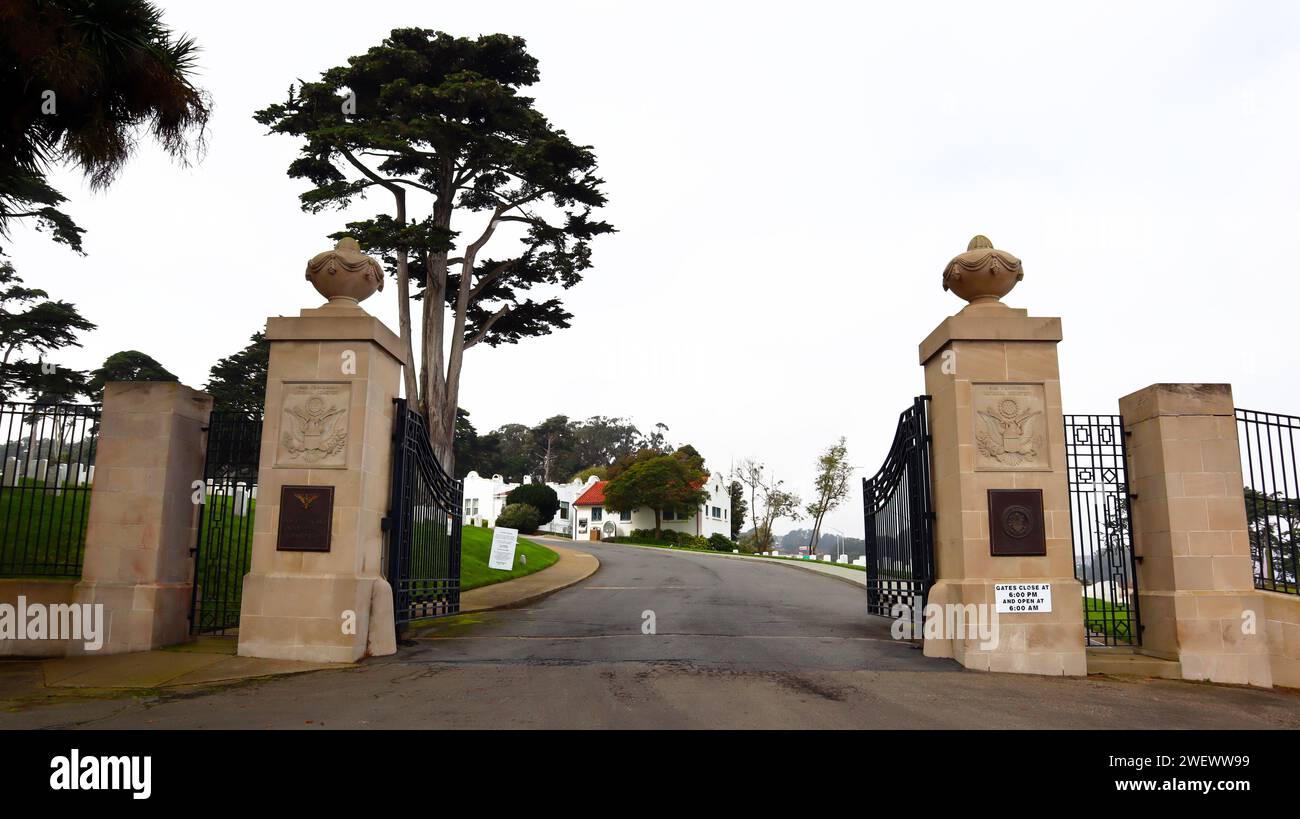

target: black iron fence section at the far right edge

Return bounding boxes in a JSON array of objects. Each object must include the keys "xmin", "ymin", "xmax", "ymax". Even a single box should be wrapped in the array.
[{"xmin": 1236, "ymin": 408, "xmax": 1300, "ymax": 594}]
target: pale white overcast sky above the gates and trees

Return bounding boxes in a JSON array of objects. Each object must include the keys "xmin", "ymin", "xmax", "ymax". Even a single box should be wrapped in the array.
[{"xmin": 10, "ymin": 0, "xmax": 1300, "ymax": 546}]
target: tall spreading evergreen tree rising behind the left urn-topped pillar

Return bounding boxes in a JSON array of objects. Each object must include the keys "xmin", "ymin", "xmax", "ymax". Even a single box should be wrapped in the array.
[{"xmin": 256, "ymin": 29, "xmax": 614, "ymax": 467}]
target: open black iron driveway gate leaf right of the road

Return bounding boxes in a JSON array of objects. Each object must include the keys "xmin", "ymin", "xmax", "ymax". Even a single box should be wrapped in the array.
[{"xmin": 862, "ymin": 395, "xmax": 935, "ymax": 618}]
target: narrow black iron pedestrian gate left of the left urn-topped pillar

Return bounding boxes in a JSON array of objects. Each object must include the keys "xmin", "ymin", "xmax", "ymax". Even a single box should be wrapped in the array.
[{"xmin": 190, "ymin": 412, "xmax": 261, "ymax": 634}]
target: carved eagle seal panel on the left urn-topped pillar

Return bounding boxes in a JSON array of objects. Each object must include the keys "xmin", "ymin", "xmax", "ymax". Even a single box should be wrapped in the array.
[{"xmin": 276, "ymin": 381, "xmax": 352, "ymax": 469}]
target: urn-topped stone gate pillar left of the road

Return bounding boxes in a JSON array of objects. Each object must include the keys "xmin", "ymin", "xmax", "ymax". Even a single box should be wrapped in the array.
[{"xmin": 239, "ymin": 239, "xmax": 404, "ymax": 662}]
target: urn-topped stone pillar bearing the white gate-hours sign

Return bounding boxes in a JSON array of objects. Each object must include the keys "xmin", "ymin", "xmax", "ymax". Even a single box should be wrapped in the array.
[{"xmin": 920, "ymin": 237, "xmax": 1087, "ymax": 675}]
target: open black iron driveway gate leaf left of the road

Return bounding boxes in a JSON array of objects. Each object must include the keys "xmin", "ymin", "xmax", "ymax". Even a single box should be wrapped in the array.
[{"xmin": 385, "ymin": 398, "xmax": 464, "ymax": 633}]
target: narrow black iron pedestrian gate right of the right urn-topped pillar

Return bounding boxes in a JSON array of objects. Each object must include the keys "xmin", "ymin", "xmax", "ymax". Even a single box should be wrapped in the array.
[{"xmin": 1065, "ymin": 415, "xmax": 1141, "ymax": 646}]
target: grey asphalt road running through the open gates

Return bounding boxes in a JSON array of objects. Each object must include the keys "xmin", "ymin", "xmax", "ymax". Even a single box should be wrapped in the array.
[{"xmin": 0, "ymin": 543, "xmax": 1300, "ymax": 729}]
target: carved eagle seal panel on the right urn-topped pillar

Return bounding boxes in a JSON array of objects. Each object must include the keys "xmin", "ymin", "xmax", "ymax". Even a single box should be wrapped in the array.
[{"xmin": 971, "ymin": 384, "xmax": 1052, "ymax": 471}]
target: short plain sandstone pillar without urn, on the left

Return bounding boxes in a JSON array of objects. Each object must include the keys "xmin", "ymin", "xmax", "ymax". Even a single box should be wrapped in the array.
[{"xmin": 69, "ymin": 382, "xmax": 212, "ymax": 654}]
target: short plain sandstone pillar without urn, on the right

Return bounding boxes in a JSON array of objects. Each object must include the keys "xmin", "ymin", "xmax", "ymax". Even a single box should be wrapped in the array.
[{"xmin": 1119, "ymin": 384, "xmax": 1271, "ymax": 686}]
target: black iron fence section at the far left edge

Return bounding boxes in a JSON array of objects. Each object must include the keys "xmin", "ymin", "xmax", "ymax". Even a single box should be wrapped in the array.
[{"xmin": 0, "ymin": 402, "xmax": 100, "ymax": 577}]
